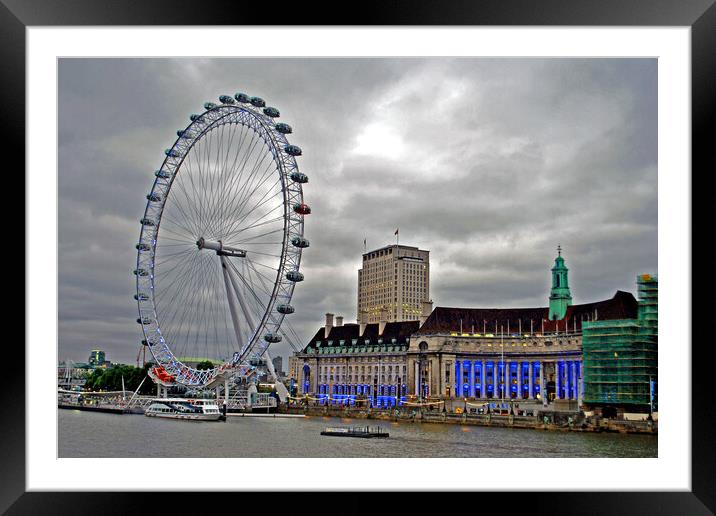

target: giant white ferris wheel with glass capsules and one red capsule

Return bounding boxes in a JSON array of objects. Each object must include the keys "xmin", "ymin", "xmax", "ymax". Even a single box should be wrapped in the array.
[{"xmin": 134, "ymin": 93, "xmax": 311, "ymax": 386}]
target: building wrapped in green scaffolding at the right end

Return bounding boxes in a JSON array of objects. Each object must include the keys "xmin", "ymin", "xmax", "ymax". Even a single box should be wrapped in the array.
[{"xmin": 582, "ymin": 274, "xmax": 658, "ymax": 409}]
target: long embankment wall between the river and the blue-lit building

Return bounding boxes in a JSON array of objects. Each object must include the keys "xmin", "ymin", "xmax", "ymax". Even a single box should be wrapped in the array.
[{"xmin": 281, "ymin": 406, "xmax": 658, "ymax": 434}]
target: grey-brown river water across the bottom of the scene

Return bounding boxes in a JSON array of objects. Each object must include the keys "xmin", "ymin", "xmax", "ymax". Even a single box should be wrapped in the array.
[{"xmin": 58, "ymin": 410, "xmax": 658, "ymax": 458}]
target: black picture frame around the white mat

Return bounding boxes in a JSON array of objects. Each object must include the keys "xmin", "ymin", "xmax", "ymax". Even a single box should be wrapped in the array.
[{"xmin": 0, "ymin": 0, "xmax": 716, "ymax": 515}]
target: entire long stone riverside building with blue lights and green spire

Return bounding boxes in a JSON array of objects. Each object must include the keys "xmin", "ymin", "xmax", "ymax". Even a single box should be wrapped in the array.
[{"xmin": 291, "ymin": 249, "xmax": 637, "ymax": 409}]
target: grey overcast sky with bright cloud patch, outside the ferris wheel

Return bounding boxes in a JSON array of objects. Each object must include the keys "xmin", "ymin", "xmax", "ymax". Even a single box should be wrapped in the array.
[{"xmin": 59, "ymin": 58, "xmax": 658, "ymax": 363}]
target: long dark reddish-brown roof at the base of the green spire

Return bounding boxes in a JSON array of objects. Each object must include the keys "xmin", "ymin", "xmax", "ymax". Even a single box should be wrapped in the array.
[{"xmin": 416, "ymin": 290, "xmax": 637, "ymax": 335}]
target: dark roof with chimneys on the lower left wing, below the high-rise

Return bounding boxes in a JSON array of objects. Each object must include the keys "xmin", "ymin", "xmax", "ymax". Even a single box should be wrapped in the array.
[{"xmin": 302, "ymin": 321, "xmax": 420, "ymax": 353}]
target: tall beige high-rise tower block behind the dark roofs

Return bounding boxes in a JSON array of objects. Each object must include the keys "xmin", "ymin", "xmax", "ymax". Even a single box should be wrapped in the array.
[{"xmin": 357, "ymin": 245, "xmax": 430, "ymax": 324}]
